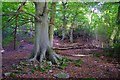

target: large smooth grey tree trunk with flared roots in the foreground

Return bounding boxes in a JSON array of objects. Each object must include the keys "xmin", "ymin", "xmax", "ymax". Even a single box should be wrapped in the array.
[{"xmin": 30, "ymin": 2, "xmax": 59, "ymax": 63}]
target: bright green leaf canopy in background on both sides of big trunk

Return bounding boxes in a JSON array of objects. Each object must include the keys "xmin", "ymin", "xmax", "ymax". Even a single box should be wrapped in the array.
[{"xmin": 2, "ymin": 2, "xmax": 119, "ymax": 50}]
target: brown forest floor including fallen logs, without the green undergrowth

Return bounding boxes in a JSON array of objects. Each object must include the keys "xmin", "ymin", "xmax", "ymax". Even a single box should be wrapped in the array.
[{"xmin": 2, "ymin": 38, "xmax": 120, "ymax": 79}]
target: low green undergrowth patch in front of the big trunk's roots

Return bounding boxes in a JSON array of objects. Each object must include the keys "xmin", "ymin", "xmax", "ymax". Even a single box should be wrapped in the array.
[{"xmin": 5, "ymin": 57, "xmax": 83, "ymax": 77}]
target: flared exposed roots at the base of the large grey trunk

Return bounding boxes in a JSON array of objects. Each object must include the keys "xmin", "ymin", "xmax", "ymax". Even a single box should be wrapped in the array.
[{"xmin": 29, "ymin": 47, "xmax": 61, "ymax": 66}]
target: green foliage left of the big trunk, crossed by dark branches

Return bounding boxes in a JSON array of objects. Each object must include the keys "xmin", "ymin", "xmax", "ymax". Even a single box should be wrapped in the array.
[{"xmin": 2, "ymin": 2, "xmax": 35, "ymax": 47}]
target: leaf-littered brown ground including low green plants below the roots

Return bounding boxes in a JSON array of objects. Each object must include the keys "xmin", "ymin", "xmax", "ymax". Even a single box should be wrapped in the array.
[{"xmin": 2, "ymin": 37, "xmax": 120, "ymax": 78}]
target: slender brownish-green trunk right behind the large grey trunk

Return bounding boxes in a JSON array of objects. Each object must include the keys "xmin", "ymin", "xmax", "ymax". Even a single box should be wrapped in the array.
[{"xmin": 49, "ymin": 2, "xmax": 56, "ymax": 47}]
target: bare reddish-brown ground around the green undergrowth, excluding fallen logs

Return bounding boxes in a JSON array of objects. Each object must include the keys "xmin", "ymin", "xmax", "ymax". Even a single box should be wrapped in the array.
[{"xmin": 2, "ymin": 38, "xmax": 120, "ymax": 78}]
